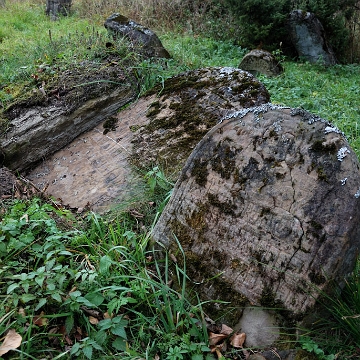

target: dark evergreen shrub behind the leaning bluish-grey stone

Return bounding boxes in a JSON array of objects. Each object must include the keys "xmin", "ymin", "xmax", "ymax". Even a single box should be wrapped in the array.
[{"xmin": 225, "ymin": 0, "xmax": 358, "ymax": 60}]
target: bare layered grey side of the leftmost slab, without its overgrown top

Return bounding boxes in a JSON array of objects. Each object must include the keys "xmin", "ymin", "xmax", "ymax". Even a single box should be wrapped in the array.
[{"xmin": 0, "ymin": 73, "xmax": 137, "ymax": 171}]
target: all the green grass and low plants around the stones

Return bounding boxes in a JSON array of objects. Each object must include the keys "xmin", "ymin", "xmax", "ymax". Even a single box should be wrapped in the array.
[{"xmin": 0, "ymin": 0, "xmax": 360, "ymax": 360}]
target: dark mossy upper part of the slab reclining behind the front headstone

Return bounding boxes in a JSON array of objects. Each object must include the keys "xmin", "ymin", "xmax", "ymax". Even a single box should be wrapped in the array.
[{"xmin": 132, "ymin": 68, "xmax": 270, "ymax": 180}]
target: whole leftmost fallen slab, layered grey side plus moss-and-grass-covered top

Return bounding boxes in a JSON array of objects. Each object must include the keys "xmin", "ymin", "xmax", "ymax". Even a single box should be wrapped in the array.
[{"xmin": 0, "ymin": 62, "xmax": 138, "ymax": 172}]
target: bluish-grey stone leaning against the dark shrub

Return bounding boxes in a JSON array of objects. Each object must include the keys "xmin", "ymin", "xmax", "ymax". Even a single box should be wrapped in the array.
[{"xmin": 287, "ymin": 10, "xmax": 337, "ymax": 66}]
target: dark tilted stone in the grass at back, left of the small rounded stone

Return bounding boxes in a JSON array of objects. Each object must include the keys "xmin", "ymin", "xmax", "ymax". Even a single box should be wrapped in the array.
[{"xmin": 104, "ymin": 13, "xmax": 171, "ymax": 59}]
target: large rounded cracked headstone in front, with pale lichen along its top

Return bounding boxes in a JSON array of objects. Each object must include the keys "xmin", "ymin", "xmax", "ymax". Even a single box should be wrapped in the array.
[{"xmin": 153, "ymin": 104, "xmax": 360, "ymax": 315}]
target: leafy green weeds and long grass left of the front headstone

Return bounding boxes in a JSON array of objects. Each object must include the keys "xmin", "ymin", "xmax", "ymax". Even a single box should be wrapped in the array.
[{"xmin": 0, "ymin": 176, "xmax": 214, "ymax": 360}]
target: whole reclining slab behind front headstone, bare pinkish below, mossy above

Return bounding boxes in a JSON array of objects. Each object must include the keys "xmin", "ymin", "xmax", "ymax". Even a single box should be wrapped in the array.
[{"xmin": 28, "ymin": 68, "xmax": 269, "ymax": 212}]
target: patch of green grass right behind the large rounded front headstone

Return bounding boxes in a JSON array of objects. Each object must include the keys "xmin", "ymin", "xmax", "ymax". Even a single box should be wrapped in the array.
[{"xmin": 260, "ymin": 62, "xmax": 360, "ymax": 157}]
